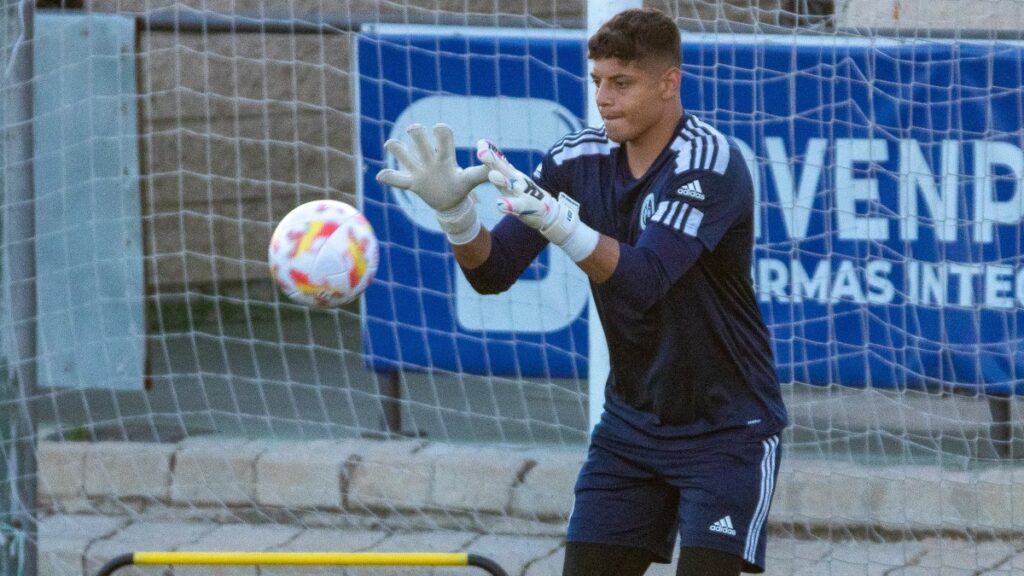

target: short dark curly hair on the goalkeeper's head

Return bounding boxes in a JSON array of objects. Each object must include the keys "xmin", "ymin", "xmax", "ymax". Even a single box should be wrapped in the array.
[{"xmin": 587, "ymin": 8, "xmax": 682, "ymax": 68}]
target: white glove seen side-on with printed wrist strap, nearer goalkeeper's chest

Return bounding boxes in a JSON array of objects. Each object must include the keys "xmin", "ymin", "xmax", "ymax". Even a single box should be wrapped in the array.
[{"xmin": 476, "ymin": 139, "xmax": 600, "ymax": 262}]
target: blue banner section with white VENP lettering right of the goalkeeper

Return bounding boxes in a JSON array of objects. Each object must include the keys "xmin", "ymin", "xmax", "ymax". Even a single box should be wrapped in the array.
[{"xmin": 683, "ymin": 36, "xmax": 1024, "ymax": 394}]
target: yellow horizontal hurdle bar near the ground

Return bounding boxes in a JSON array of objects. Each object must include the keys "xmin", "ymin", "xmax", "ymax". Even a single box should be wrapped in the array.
[{"xmin": 132, "ymin": 551, "xmax": 469, "ymax": 566}]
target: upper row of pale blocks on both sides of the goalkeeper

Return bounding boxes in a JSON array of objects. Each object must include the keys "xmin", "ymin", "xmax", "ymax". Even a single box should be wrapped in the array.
[{"xmin": 46, "ymin": 438, "xmax": 1024, "ymax": 535}]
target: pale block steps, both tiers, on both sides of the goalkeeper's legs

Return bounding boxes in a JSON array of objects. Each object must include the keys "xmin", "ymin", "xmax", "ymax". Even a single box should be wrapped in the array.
[{"xmin": 32, "ymin": 438, "xmax": 1024, "ymax": 576}]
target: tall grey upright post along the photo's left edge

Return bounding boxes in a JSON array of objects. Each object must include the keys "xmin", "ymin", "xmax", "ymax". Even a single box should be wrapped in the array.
[{"xmin": 0, "ymin": 0, "xmax": 38, "ymax": 576}]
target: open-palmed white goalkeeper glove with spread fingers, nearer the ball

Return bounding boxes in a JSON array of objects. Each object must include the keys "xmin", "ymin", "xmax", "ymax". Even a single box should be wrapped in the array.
[{"xmin": 377, "ymin": 124, "xmax": 487, "ymax": 244}]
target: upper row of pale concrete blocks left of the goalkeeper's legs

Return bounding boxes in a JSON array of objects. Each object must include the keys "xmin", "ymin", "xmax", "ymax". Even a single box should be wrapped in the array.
[{"xmin": 39, "ymin": 438, "xmax": 583, "ymax": 522}]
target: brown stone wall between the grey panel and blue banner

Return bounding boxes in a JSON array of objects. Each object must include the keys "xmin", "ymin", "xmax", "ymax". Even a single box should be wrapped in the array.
[{"xmin": 138, "ymin": 33, "xmax": 357, "ymax": 286}]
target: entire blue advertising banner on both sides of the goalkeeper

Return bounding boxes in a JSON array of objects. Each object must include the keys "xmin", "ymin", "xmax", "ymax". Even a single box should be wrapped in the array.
[{"xmin": 358, "ymin": 29, "xmax": 1024, "ymax": 394}]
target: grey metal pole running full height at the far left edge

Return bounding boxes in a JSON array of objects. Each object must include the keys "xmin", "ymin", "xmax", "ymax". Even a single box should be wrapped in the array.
[{"xmin": 0, "ymin": 0, "xmax": 38, "ymax": 576}]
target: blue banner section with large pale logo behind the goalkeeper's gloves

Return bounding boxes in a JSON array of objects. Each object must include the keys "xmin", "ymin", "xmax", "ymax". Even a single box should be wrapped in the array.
[{"xmin": 356, "ymin": 27, "xmax": 590, "ymax": 378}]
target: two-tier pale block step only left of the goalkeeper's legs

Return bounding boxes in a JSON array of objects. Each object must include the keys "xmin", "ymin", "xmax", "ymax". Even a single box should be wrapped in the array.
[{"xmin": 39, "ymin": 438, "xmax": 583, "ymax": 576}]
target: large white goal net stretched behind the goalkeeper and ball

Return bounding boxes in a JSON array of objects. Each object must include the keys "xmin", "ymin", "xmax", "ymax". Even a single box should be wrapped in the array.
[{"xmin": 6, "ymin": 0, "xmax": 1024, "ymax": 575}]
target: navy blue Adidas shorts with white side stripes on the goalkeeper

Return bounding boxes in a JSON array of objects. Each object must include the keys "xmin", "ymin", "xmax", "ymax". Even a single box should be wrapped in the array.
[{"xmin": 567, "ymin": 401, "xmax": 780, "ymax": 572}]
